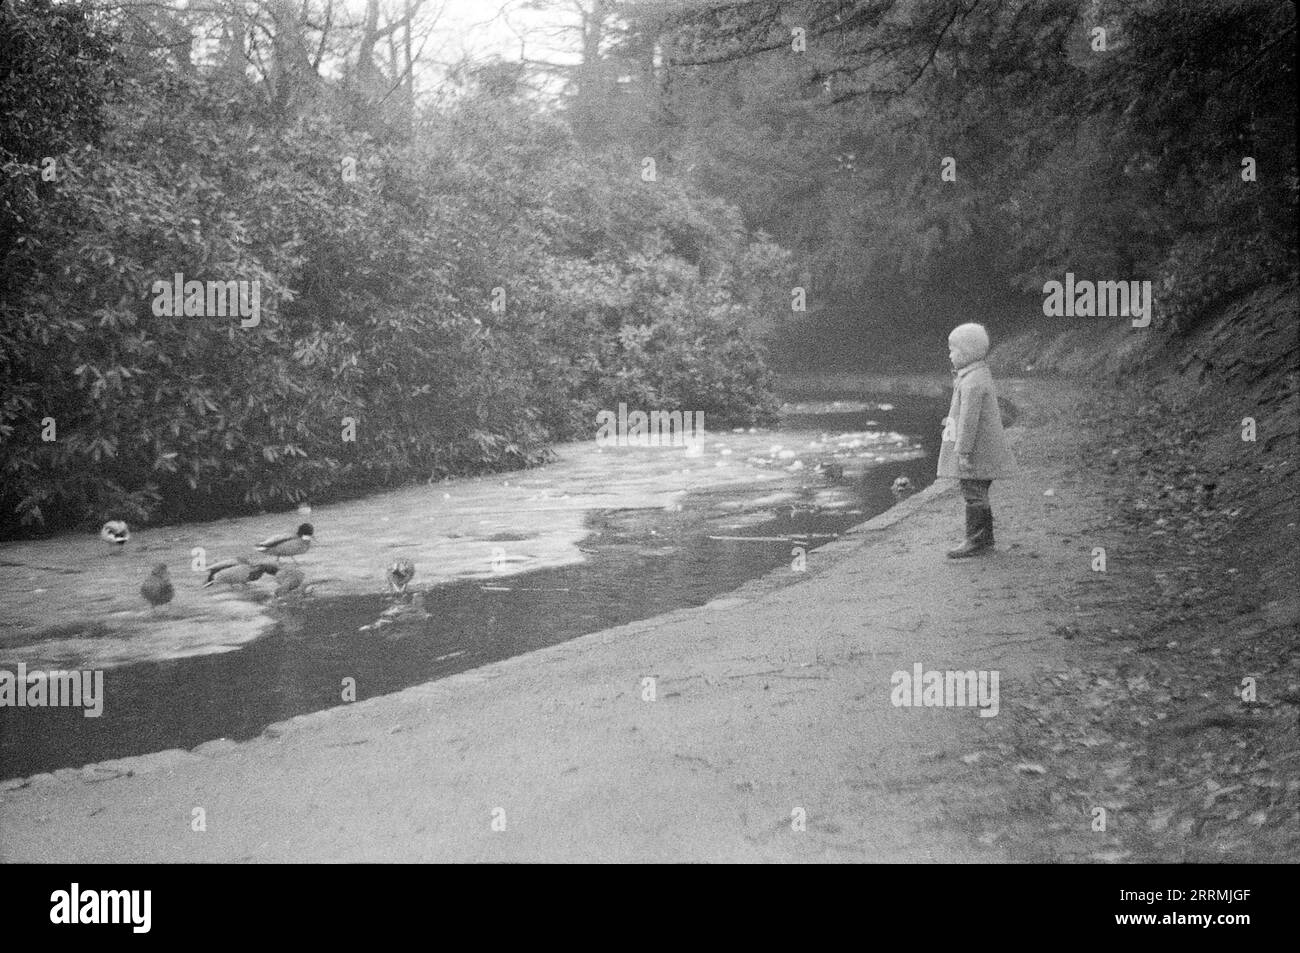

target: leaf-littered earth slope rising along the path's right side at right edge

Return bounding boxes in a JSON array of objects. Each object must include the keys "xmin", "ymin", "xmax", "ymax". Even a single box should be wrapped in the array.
[{"xmin": 992, "ymin": 286, "xmax": 1300, "ymax": 861}]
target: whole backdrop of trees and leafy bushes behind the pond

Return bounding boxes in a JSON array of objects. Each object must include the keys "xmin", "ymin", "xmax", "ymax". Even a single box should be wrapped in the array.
[{"xmin": 0, "ymin": 0, "xmax": 1300, "ymax": 532}]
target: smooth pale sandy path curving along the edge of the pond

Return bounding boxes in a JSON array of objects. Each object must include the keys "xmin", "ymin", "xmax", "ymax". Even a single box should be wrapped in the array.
[{"xmin": 0, "ymin": 374, "xmax": 1118, "ymax": 862}]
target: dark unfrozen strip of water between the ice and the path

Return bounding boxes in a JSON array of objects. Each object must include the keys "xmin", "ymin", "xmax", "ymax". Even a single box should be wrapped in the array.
[{"xmin": 0, "ymin": 394, "xmax": 944, "ymax": 777}]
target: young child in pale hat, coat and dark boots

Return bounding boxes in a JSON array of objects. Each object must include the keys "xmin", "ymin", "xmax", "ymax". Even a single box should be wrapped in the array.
[{"xmin": 939, "ymin": 324, "xmax": 1015, "ymax": 559}]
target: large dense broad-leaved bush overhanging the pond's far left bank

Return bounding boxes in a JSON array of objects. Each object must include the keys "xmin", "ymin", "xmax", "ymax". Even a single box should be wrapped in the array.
[{"xmin": 0, "ymin": 1, "xmax": 785, "ymax": 533}]
